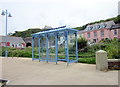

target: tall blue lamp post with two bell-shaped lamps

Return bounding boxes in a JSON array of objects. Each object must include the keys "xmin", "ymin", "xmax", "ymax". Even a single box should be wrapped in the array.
[{"xmin": 1, "ymin": 9, "xmax": 12, "ymax": 57}]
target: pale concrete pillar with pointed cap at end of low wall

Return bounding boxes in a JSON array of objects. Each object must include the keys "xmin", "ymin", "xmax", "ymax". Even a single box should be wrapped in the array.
[{"xmin": 96, "ymin": 50, "xmax": 108, "ymax": 71}]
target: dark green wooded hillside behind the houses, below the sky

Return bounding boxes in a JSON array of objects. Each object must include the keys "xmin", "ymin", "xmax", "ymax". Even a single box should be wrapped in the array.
[{"xmin": 12, "ymin": 15, "xmax": 120, "ymax": 38}]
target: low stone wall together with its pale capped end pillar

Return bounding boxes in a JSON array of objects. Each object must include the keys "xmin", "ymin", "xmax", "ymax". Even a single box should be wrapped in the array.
[{"xmin": 96, "ymin": 50, "xmax": 120, "ymax": 71}]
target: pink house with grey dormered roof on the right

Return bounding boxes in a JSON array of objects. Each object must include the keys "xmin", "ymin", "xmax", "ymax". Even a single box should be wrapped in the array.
[{"xmin": 78, "ymin": 21, "xmax": 120, "ymax": 44}]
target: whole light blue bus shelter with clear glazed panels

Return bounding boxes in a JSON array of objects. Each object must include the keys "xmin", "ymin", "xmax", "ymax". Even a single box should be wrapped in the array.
[{"xmin": 31, "ymin": 28, "xmax": 78, "ymax": 65}]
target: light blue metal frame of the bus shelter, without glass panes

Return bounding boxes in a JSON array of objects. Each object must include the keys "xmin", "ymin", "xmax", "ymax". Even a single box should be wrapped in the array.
[{"xmin": 31, "ymin": 28, "xmax": 78, "ymax": 65}]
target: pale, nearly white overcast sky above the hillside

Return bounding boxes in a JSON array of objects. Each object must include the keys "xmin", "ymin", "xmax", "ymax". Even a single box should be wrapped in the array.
[{"xmin": 0, "ymin": 0, "xmax": 119, "ymax": 35}]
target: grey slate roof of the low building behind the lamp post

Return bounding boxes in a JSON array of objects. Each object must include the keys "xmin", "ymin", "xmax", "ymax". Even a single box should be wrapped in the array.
[{"xmin": 0, "ymin": 36, "xmax": 25, "ymax": 44}]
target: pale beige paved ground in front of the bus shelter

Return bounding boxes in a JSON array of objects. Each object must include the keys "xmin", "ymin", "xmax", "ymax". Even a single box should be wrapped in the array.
[{"xmin": 0, "ymin": 58, "xmax": 118, "ymax": 85}]
